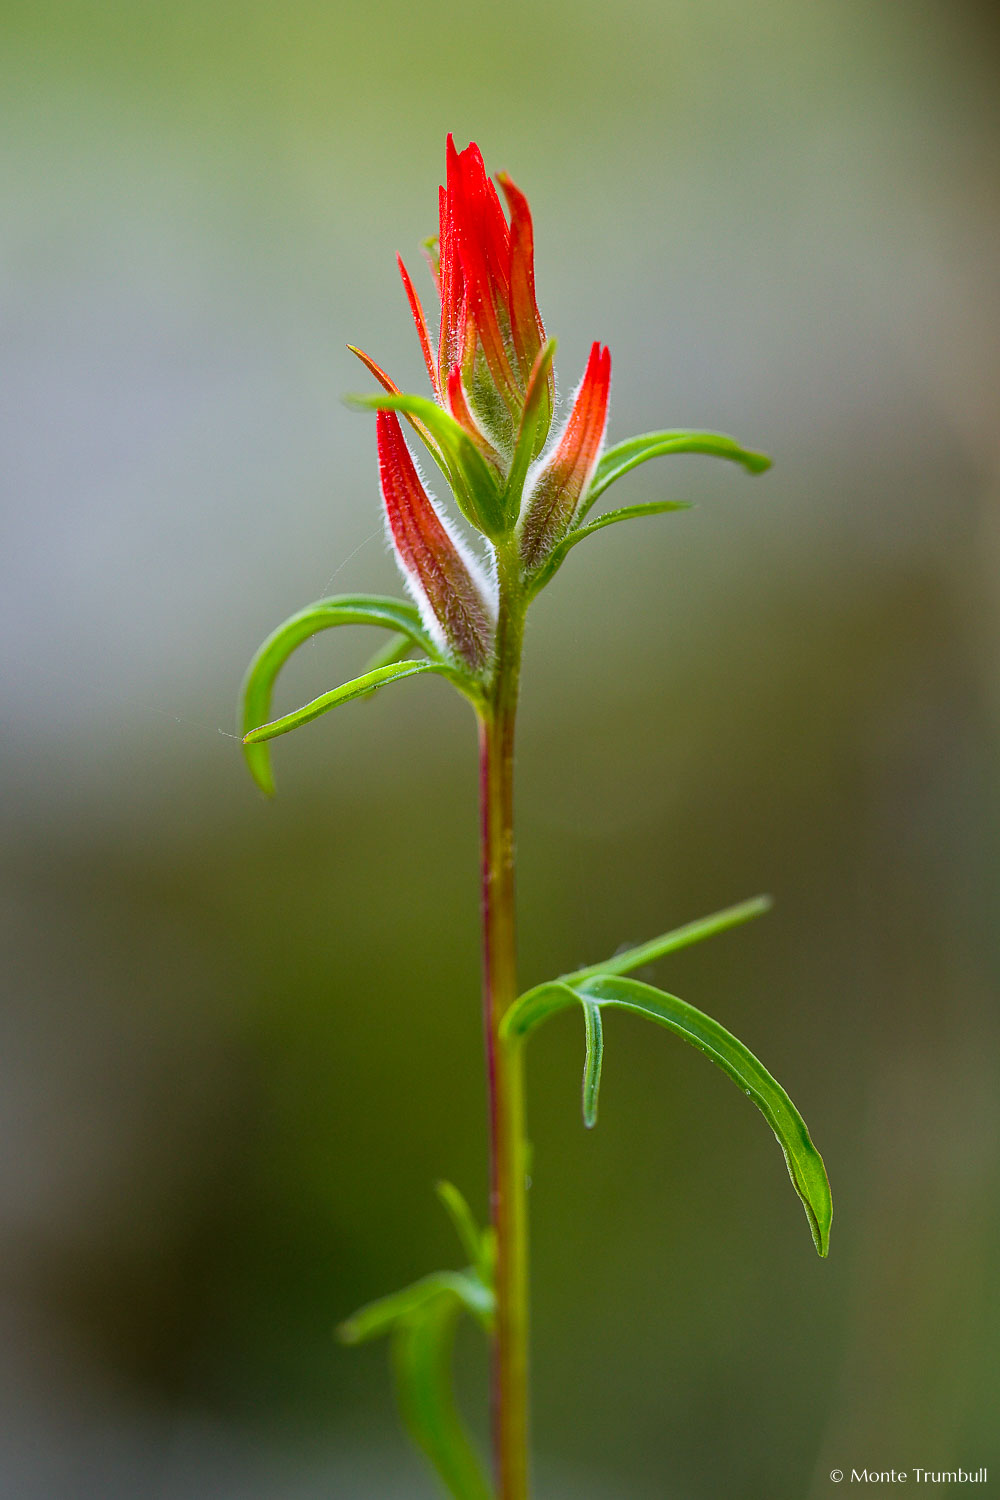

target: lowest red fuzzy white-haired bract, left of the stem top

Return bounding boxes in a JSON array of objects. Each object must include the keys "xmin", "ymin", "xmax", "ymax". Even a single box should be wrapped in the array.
[{"xmin": 376, "ymin": 411, "xmax": 495, "ymax": 672}]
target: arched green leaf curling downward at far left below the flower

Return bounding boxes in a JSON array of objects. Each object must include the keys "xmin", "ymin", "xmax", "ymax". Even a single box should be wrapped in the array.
[{"xmin": 240, "ymin": 594, "xmax": 438, "ymax": 795}]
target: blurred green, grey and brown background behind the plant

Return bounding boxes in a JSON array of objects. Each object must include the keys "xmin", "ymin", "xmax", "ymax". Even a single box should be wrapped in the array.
[{"xmin": 0, "ymin": 0, "xmax": 1000, "ymax": 1500}]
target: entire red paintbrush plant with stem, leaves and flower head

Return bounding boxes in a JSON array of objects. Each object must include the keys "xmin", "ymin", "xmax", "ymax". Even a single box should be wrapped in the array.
[{"xmin": 243, "ymin": 137, "xmax": 803, "ymax": 1500}]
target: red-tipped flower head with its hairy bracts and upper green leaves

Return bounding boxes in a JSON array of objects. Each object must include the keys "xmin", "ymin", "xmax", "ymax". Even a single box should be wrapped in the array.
[{"xmin": 338, "ymin": 137, "xmax": 768, "ymax": 651}]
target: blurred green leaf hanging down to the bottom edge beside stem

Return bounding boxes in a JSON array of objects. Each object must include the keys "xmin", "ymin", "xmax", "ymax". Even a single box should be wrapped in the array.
[{"xmin": 393, "ymin": 1296, "xmax": 493, "ymax": 1500}]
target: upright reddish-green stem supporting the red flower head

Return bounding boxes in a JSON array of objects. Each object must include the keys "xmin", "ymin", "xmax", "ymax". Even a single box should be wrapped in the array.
[{"xmin": 480, "ymin": 546, "xmax": 528, "ymax": 1500}]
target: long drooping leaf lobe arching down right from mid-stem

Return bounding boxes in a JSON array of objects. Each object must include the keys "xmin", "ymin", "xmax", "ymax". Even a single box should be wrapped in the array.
[{"xmin": 574, "ymin": 975, "xmax": 834, "ymax": 1256}]
